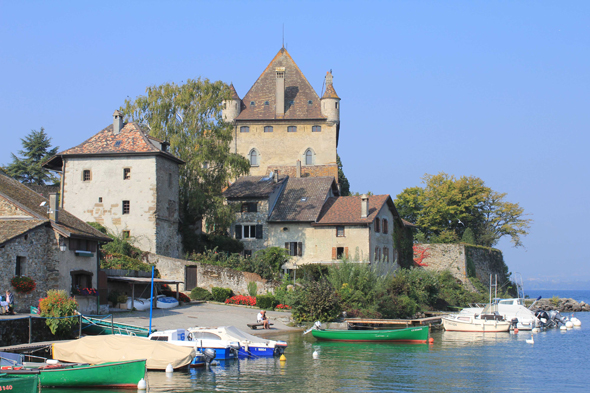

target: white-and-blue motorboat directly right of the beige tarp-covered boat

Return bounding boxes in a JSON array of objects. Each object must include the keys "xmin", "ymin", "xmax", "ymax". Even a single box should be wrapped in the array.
[{"xmin": 148, "ymin": 329, "xmax": 239, "ymax": 360}]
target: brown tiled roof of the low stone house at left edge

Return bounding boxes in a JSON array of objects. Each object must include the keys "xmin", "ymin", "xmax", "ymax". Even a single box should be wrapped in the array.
[{"xmin": 0, "ymin": 173, "xmax": 110, "ymax": 241}]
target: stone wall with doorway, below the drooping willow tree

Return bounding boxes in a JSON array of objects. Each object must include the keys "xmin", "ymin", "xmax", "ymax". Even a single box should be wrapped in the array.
[{"xmin": 148, "ymin": 253, "xmax": 279, "ymax": 295}]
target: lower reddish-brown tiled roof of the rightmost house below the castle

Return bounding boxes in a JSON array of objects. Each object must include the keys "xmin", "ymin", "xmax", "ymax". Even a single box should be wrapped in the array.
[{"xmin": 317, "ymin": 195, "xmax": 397, "ymax": 225}]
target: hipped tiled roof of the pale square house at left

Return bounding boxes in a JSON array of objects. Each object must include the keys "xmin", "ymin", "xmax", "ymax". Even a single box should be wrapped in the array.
[{"xmin": 43, "ymin": 123, "xmax": 183, "ymax": 169}]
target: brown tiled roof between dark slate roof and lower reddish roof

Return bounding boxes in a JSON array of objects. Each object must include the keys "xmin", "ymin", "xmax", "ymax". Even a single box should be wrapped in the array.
[{"xmin": 268, "ymin": 176, "xmax": 337, "ymax": 222}]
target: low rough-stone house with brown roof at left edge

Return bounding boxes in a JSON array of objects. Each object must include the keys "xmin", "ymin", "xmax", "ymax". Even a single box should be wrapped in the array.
[{"xmin": 0, "ymin": 171, "xmax": 110, "ymax": 312}]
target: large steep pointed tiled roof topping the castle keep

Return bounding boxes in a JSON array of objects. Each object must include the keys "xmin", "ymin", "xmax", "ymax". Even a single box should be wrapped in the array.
[{"xmin": 236, "ymin": 48, "xmax": 326, "ymax": 120}]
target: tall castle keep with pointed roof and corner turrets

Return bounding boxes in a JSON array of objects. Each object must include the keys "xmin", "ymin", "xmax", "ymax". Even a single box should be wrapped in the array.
[{"xmin": 223, "ymin": 48, "xmax": 340, "ymax": 179}]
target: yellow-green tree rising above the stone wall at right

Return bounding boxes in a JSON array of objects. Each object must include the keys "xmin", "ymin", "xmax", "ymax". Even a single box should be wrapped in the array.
[{"xmin": 395, "ymin": 172, "xmax": 532, "ymax": 247}]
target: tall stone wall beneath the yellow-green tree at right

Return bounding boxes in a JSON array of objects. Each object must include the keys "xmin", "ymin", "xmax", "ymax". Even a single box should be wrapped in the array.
[{"xmin": 414, "ymin": 244, "xmax": 507, "ymax": 290}]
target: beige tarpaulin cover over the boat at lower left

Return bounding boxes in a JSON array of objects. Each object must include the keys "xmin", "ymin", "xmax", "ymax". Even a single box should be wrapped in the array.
[{"xmin": 52, "ymin": 335, "xmax": 195, "ymax": 370}]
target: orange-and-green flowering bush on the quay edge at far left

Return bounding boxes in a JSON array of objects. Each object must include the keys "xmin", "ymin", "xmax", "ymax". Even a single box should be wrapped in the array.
[{"xmin": 39, "ymin": 289, "xmax": 78, "ymax": 337}]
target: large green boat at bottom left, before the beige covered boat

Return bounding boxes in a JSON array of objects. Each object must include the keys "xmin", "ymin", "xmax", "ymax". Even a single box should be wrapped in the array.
[{"xmin": 0, "ymin": 359, "xmax": 146, "ymax": 392}]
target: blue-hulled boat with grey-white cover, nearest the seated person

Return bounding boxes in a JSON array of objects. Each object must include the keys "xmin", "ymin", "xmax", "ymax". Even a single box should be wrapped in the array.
[{"xmin": 187, "ymin": 326, "xmax": 287, "ymax": 357}]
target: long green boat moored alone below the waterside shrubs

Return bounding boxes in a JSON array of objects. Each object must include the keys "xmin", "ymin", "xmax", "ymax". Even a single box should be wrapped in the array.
[{"xmin": 311, "ymin": 326, "xmax": 428, "ymax": 343}]
